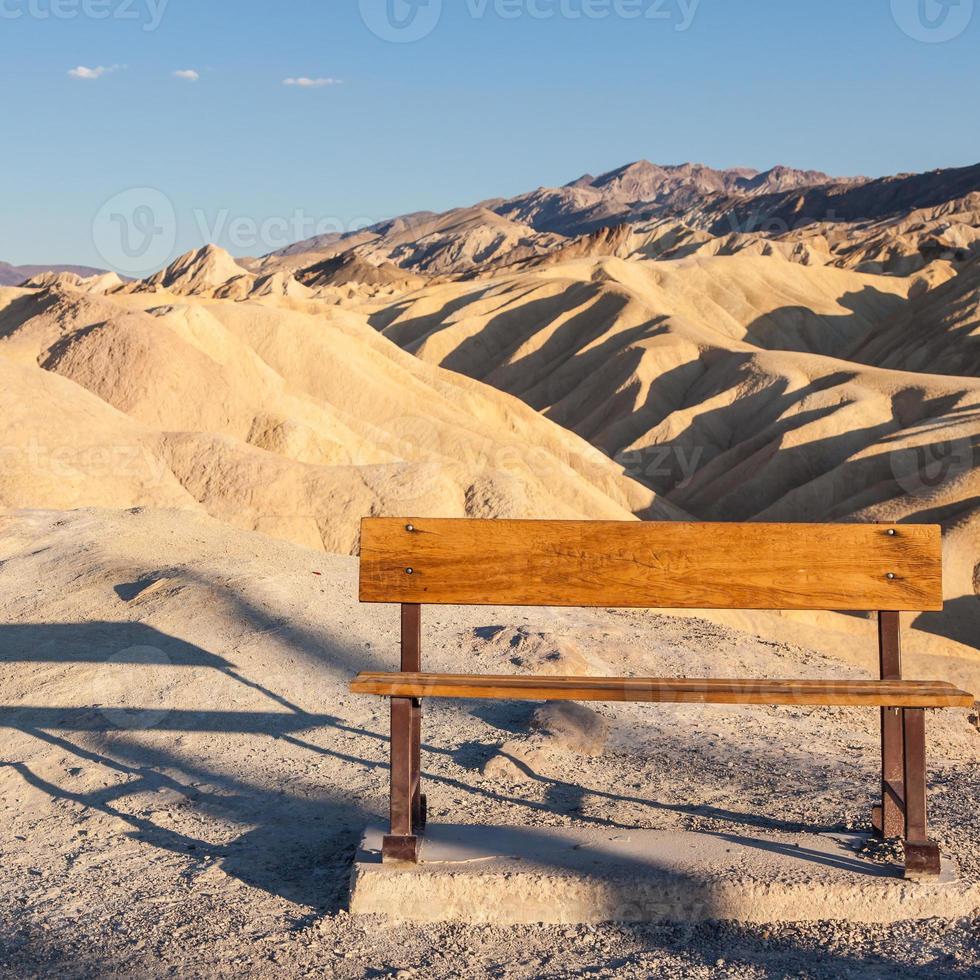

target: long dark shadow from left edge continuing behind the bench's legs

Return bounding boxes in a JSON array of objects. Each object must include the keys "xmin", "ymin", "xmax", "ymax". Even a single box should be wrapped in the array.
[{"xmin": 0, "ymin": 622, "xmax": 888, "ymax": 908}]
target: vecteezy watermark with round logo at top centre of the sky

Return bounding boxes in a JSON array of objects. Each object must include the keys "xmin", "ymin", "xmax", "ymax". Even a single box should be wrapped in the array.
[{"xmin": 360, "ymin": 0, "xmax": 700, "ymax": 43}]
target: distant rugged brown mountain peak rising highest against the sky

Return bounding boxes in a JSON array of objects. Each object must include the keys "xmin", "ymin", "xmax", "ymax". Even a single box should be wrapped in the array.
[{"xmin": 260, "ymin": 159, "xmax": 980, "ymax": 280}]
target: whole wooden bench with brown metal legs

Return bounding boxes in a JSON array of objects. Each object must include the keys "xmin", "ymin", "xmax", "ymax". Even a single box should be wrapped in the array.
[{"xmin": 351, "ymin": 518, "xmax": 973, "ymax": 877}]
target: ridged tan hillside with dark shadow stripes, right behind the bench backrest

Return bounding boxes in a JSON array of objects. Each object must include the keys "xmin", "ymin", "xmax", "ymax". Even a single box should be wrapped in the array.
[{"xmin": 372, "ymin": 255, "xmax": 980, "ymax": 655}]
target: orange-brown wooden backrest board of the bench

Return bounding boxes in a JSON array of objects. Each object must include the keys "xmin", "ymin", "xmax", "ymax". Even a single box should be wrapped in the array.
[{"xmin": 360, "ymin": 518, "xmax": 942, "ymax": 611}]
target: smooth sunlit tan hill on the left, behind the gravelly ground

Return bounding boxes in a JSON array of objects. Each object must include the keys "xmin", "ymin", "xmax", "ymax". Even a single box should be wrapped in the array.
[{"xmin": 0, "ymin": 264, "xmax": 679, "ymax": 553}]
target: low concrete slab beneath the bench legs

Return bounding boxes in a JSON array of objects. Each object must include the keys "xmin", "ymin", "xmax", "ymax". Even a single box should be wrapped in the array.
[{"xmin": 350, "ymin": 824, "xmax": 980, "ymax": 924}]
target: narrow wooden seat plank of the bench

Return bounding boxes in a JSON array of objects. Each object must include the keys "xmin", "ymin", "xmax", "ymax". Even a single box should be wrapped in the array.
[{"xmin": 351, "ymin": 672, "xmax": 973, "ymax": 708}]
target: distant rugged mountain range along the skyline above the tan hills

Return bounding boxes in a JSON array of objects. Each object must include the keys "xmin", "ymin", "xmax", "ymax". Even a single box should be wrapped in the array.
[{"xmin": 253, "ymin": 160, "xmax": 980, "ymax": 275}]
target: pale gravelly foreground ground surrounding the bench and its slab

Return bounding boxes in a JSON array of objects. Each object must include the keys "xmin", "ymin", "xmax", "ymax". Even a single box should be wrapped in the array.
[{"xmin": 0, "ymin": 511, "xmax": 980, "ymax": 978}]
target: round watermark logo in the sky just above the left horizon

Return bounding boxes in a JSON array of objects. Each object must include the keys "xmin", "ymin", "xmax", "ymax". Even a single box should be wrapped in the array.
[{"xmin": 92, "ymin": 187, "xmax": 177, "ymax": 276}]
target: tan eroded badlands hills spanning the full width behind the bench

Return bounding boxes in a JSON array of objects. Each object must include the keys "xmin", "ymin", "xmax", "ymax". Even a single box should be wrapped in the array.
[{"xmin": 0, "ymin": 180, "xmax": 980, "ymax": 676}]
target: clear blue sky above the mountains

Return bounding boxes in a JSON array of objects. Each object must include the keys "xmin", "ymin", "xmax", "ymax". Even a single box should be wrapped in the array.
[{"xmin": 0, "ymin": 0, "xmax": 980, "ymax": 266}]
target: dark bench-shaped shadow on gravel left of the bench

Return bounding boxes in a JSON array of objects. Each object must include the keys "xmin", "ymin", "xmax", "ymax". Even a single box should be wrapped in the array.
[{"xmin": 0, "ymin": 622, "xmax": 381, "ymax": 914}]
